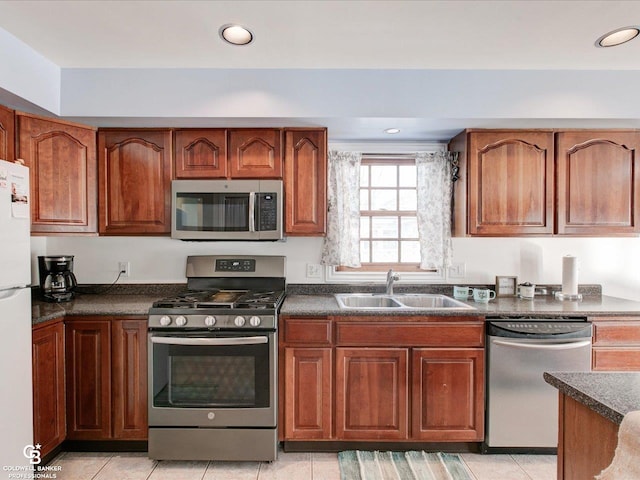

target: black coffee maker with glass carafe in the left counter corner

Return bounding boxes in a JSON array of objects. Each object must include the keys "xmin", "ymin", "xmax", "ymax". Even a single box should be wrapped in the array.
[{"xmin": 38, "ymin": 255, "xmax": 78, "ymax": 302}]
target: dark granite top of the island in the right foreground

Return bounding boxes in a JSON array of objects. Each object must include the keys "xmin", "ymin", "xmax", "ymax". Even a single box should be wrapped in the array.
[{"xmin": 544, "ymin": 372, "xmax": 640, "ymax": 425}]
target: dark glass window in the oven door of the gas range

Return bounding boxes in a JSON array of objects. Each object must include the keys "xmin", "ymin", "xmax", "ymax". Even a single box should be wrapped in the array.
[{"xmin": 153, "ymin": 344, "xmax": 270, "ymax": 408}]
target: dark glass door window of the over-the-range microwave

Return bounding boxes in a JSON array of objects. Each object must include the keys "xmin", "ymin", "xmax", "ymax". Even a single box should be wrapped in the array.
[{"xmin": 175, "ymin": 193, "xmax": 249, "ymax": 232}]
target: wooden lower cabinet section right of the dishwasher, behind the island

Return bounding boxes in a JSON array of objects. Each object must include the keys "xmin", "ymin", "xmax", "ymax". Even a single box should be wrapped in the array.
[{"xmin": 590, "ymin": 317, "xmax": 640, "ymax": 371}]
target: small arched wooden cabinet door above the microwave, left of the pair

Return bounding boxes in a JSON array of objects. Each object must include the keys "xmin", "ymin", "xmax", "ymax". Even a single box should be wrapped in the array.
[{"xmin": 175, "ymin": 129, "xmax": 227, "ymax": 178}]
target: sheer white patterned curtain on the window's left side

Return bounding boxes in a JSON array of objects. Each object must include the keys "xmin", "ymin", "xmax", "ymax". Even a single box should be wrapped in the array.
[{"xmin": 322, "ymin": 151, "xmax": 362, "ymax": 267}]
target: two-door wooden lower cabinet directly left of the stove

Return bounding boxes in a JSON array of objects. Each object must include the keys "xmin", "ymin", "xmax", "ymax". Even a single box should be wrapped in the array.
[{"xmin": 66, "ymin": 317, "xmax": 147, "ymax": 440}]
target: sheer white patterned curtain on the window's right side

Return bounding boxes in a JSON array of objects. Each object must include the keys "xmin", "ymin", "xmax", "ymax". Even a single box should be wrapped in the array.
[{"xmin": 416, "ymin": 152, "xmax": 457, "ymax": 270}]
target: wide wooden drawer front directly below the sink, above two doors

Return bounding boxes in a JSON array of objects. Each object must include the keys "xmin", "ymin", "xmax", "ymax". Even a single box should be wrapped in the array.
[{"xmin": 336, "ymin": 322, "xmax": 484, "ymax": 347}]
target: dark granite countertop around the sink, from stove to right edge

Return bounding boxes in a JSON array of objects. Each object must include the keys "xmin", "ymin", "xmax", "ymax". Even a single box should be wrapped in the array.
[{"xmin": 280, "ymin": 294, "xmax": 640, "ymax": 317}]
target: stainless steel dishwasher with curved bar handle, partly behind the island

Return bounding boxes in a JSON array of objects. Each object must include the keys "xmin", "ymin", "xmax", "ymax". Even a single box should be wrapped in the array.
[{"xmin": 483, "ymin": 318, "xmax": 591, "ymax": 453}]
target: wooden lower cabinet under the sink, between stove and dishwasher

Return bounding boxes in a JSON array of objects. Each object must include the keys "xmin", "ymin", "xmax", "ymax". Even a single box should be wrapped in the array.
[{"xmin": 280, "ymin": 317, "xmax": 485, "ymax": 442}]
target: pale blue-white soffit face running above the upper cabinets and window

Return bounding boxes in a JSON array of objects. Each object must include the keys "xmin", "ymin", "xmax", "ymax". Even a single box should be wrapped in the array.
[{"xmin": 61, "ymin": 68, "xmax": 640, "ymax": 120}]
